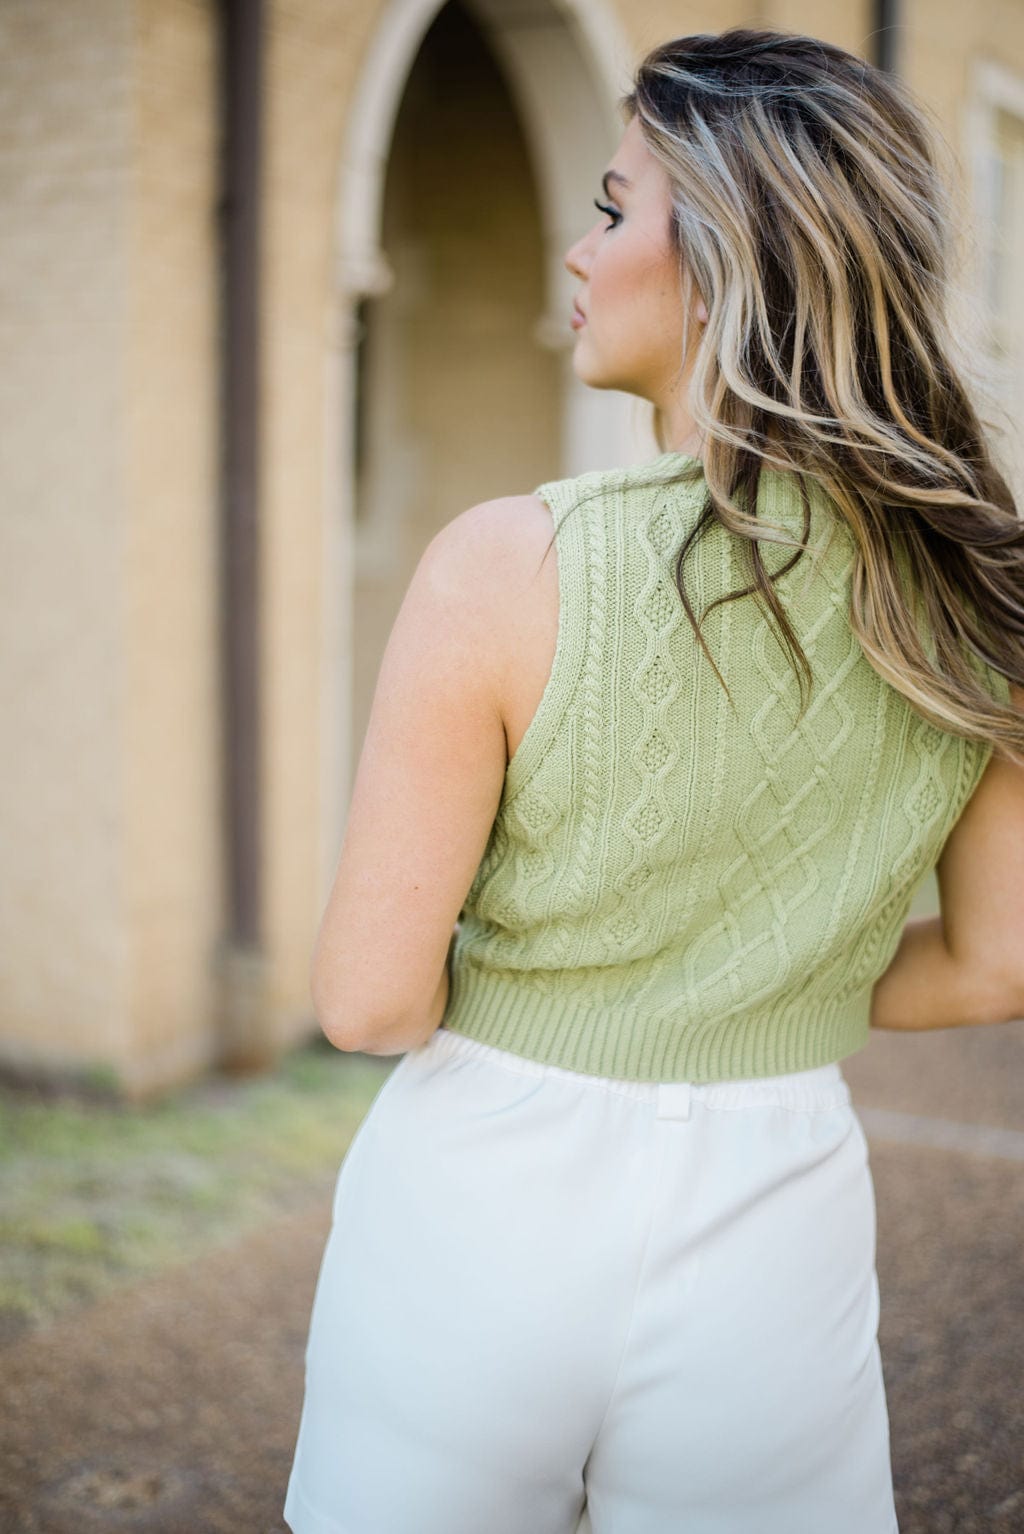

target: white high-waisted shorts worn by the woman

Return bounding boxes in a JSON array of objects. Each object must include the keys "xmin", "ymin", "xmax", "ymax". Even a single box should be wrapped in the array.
[{"xmin": 284, "ymin": 1028, "xmax": 897, "ymax": 1534}]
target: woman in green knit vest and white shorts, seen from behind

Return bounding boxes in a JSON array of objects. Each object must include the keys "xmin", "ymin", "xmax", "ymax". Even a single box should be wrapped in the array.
[{"xmin": 285, "ymin": 29, "xmax": 1024, "ymax": 1534}]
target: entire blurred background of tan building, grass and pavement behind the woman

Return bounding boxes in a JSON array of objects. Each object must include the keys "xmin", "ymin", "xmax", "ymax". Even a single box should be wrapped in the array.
[{"xmin": 0, "ymin": 0, "xmax": 1024, "ymax": 1534}]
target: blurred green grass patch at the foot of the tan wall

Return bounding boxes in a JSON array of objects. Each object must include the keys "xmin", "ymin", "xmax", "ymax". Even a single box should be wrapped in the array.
[{"xmin": 0, "ymin": 1039, "xmax": 399, "ymax": 1336}]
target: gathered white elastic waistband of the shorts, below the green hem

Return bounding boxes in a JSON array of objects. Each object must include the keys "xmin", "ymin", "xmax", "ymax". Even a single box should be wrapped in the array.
[{"xmin": 420, "ymin": 1026, "xmax": 851, "ymax": 1117}]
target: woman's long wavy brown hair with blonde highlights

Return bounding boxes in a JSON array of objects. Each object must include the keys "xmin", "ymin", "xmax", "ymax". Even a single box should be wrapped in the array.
[{"xmin": 591, "ymin": 28, "xmax": 1024, "ymax": 765}]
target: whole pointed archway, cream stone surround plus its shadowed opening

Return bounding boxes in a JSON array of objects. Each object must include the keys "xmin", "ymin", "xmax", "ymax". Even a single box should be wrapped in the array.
[{"xmin": 322, "ymin": 0, "xmax": 650, "ymax": 893}]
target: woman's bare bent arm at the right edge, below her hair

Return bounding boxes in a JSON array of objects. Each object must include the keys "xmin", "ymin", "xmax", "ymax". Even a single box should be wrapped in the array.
[{"xmin": 871, "ymin": 687, "xmax": 1024, "ymax": 1029}]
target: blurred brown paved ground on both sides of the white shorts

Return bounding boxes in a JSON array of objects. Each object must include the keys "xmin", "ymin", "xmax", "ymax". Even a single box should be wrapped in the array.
[{"xmin": 0, "ymin": 1023, "xmax": 1024, "ymax": 1534}]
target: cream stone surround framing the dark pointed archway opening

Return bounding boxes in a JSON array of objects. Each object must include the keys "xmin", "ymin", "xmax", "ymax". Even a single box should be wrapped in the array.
[{"xmin": 320, "ymin": 0, "xmax": 646, "ymax": 891}]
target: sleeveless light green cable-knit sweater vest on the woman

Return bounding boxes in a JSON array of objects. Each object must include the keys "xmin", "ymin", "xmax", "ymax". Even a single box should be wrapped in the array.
[{"xmin": 441, "ymin": 453, "xmax": 1009, "ymax": 1081}]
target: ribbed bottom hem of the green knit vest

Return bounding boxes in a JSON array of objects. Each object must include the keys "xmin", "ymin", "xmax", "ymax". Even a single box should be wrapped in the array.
[{"xmin": 445, "ymin": 963, "xmax": 871, "ymax": 1083}]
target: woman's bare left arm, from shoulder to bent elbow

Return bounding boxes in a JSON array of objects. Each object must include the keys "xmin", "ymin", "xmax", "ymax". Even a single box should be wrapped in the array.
[{"xmin": 310, "ymin": 495, "xmax": 508, "ymax": 1054}]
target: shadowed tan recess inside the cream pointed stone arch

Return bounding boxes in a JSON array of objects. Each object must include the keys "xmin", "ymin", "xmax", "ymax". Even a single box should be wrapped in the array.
[{"xmin": 353, "ymin": 0, "xmax": 561, "ymax": 765}]
